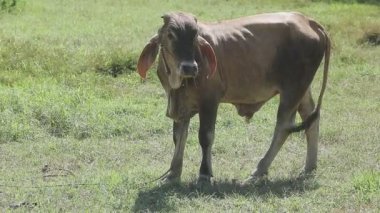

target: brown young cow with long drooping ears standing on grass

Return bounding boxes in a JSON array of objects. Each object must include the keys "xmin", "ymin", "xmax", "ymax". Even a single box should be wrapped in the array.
[{"xmin": 137, "ymin": 12, "xmax": 330, "ymax": 183}]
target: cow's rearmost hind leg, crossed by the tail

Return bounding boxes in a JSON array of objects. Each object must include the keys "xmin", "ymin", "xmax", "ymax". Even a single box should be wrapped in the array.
[{"xmin": 298, "ymin": 89, "xmax": 319, "ymax": 174}]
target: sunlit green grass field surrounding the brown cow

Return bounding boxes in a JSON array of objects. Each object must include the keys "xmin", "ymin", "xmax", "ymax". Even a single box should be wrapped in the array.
[{"xmin": 0, "ymin": 0, "xmax": 380, "ymax": 212}]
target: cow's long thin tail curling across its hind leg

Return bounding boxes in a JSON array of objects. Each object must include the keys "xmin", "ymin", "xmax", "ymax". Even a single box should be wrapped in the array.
[{"xmin": 288, "ymin": 24, "xmax": 331, "ymax": 133}]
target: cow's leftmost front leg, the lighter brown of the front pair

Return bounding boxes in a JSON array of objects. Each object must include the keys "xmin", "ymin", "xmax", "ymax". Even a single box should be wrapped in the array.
[{"xmin": 161, "ymin": 118, "xmax": 190, "ymax": 184}]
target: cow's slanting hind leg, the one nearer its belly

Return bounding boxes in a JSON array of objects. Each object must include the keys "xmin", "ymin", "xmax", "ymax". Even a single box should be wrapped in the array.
[{"xmin": 243, "ymin": 95, "xmax": 299, "ymax": 185}]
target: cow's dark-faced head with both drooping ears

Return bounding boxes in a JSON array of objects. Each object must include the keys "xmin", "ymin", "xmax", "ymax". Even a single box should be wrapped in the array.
[{"xmin": 137, "ymin": 13, "xmax": 216, "ymax": 89}]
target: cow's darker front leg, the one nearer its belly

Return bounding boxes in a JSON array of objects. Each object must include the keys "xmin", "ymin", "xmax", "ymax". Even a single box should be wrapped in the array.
[{"xmin": 198, "ymin": 103, "xmax": 218, "ymax": 184}]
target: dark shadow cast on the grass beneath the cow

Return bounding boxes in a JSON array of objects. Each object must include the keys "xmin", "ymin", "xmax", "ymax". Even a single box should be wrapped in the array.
[{"xmin": 133, "ymin": 178, "xmax": 319, "ymax": 212}]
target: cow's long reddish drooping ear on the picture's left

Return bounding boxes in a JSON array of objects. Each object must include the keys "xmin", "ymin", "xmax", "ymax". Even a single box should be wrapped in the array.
[{"xmin": 137, "ymin": 35, "xmax": 159, "ymax": 79}]
